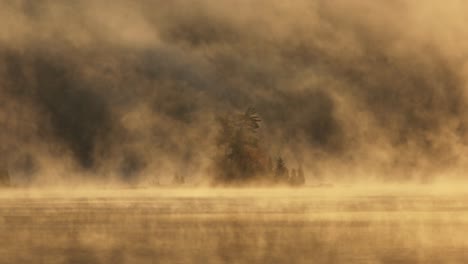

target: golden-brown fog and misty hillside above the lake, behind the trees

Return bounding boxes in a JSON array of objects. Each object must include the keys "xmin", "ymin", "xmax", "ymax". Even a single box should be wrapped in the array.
[{"xmin": 0, "ymin": 0, "xmax": 468, "ymax": 186}]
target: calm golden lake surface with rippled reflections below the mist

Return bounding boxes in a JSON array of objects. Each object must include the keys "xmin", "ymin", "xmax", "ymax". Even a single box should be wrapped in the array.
[{"xmin": 0, "ymin": 189, "xmax": 468, "ymax": 264}]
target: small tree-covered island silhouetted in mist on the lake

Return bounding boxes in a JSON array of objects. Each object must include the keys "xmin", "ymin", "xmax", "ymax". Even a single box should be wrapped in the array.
[{"xmin": 214, "ymin": 107, "xmax": 305, "ymax": 186}]
